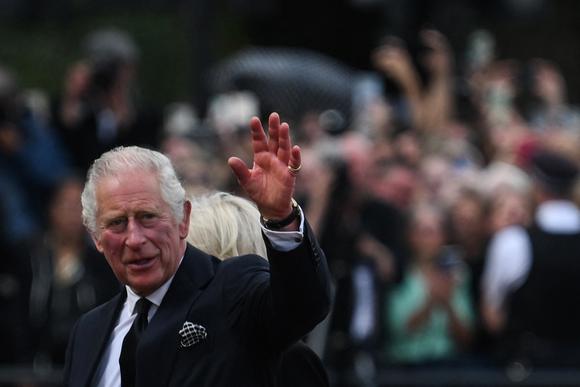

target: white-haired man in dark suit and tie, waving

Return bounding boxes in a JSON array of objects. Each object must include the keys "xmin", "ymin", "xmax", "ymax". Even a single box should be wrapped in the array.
[{"xmin": 65, "ymin": 113, "xmax": 330, "ymax": 387}]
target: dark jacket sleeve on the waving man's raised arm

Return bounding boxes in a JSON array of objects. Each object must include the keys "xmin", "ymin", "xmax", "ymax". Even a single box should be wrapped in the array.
[{"xmin": 225, "ymin": 222, "xmax": 331, "ymax": 351}]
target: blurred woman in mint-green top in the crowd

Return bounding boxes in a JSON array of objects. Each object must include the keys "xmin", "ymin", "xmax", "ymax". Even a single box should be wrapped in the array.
[{"xmin": 385, "ymin": 204, "xmax": 475, "ymax": 364}]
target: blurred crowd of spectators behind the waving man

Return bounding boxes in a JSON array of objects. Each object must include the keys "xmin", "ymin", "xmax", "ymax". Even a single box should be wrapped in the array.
[{"xmin": 0, "ymin": 24, "xmax": 580, "ymax": 385}]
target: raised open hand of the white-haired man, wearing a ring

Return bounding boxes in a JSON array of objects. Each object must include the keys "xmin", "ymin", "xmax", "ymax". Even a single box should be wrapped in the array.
[{"xmin": 228, "ymin": 113, "xmax": 301, "ymax": 223}]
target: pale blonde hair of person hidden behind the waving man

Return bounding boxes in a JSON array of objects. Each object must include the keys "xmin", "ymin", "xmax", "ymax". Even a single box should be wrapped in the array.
[{"xmin": 188, "ymin": 192, "xmax": 267, "ymax": 259}]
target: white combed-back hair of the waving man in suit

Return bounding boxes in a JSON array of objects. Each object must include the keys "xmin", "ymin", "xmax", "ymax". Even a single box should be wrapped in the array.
[{"xmin": 81, "ymin": 146, "xmax": 185, "ymax": 234}]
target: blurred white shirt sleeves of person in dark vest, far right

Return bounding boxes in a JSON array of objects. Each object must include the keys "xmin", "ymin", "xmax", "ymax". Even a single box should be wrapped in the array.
[{"xmin": 481, "ymin": 200, "xmax": 580, "ymax": 309}]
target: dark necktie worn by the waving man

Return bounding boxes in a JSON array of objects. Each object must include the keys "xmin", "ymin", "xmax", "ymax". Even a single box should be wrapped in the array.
[{"xmin": 119, "ymin": 298, "xmax": 151, "ymax": 387}]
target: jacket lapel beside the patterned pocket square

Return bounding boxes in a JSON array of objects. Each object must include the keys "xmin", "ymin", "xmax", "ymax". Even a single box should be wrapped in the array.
[{"xmin": 136, "ymin": 245, "xmax": 214, "ymax": 386}]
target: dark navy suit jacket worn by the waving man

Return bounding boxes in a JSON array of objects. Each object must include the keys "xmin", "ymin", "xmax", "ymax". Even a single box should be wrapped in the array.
[{"xmin": 65, "ymin": 226, "xmax": 330, "ymax": 387}]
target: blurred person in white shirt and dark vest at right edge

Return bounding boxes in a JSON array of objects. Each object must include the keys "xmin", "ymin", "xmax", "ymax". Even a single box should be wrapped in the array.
[{"xmin": 481, "ymin": 150, "xmax": 580, "ymax": 364}]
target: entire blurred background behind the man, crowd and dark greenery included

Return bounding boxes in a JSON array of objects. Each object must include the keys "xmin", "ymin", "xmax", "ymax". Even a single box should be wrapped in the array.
[{"xmin": 0, "ymin": 0, "xmax": 580, "ymax": 386}]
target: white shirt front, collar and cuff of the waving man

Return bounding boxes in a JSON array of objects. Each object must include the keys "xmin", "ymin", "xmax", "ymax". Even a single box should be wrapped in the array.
[{"xmin": 95, "ymin": 212, "xmax": 304, "ymax": 387}]
